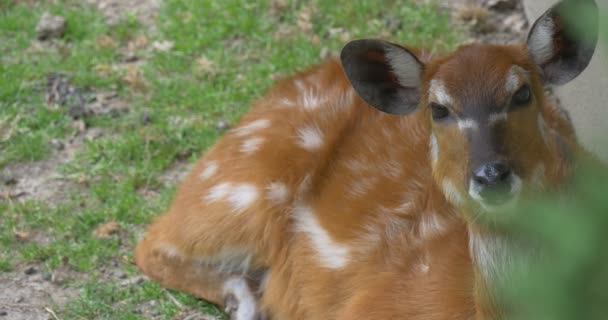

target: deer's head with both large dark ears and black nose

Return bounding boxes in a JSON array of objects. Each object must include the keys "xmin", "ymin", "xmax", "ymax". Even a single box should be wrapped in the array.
[{"xmin": 341, "ymin": 1, "xmax": 597, "ymax": 218}]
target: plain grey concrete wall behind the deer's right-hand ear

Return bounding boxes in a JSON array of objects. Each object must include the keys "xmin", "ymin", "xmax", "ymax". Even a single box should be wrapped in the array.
[{"xmin": 523, "ymin": 0, "xmax": 608, "ymax": 163}]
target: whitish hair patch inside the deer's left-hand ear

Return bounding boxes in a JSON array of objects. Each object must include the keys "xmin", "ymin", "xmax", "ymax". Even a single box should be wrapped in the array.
[{"xmin": 385, "ymin": 45, "xmax": 422, "ymax": 87}]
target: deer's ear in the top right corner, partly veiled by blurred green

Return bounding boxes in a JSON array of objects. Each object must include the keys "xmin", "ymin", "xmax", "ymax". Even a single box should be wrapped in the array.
[{"xmin": 527, "ymin": 0, "xmax": 598, "ymax": 85}]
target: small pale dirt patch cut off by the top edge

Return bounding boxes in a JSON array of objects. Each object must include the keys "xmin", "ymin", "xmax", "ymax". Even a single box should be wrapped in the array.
[{"xmin": 87, "ymin": 0, "xmax": 162, "ymax": 25}]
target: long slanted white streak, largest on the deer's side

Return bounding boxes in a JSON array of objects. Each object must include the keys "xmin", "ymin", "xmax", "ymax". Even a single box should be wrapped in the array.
[{"xmin": 293, "ymin": 206, "xmax": 350, "ymax": 269}]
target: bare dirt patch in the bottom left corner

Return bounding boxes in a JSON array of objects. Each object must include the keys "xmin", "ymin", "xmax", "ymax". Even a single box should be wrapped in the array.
[{"xmin": 0, "ymin": 265, "xmax": 78, "ymax": 320}]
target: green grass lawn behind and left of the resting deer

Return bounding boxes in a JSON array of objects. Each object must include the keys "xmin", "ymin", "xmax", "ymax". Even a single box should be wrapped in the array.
[{"xmin": 0, "ymin": 0, "xmax": 458, "ymax": 319}]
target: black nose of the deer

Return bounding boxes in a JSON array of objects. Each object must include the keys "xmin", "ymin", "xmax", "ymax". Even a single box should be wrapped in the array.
[{"xmin": 473, "ymin": 161, "xmax": 511, "ymax": 194}]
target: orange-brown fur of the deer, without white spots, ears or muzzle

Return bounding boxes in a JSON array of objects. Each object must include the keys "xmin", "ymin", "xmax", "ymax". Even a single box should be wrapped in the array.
[{"xmin": 136, "ymin": 42, "xmax": 578, "ymax": 320}]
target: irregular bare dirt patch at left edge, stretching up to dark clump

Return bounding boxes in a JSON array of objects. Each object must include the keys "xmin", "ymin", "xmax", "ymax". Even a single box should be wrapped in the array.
[{"xmin": 0, "ymin": 73, "xmax": 130, "ymax": 205}]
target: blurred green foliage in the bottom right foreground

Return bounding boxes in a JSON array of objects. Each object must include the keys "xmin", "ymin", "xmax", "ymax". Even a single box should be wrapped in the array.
[{"xmin": 502, "ymin": 162, "xmax": 608, "ymax": 320}]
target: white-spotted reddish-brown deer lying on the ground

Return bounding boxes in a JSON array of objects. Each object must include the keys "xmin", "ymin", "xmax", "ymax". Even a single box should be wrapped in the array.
[{"xmin": 135, "ymin": 1, "xmax": 597, "ymax": 320}]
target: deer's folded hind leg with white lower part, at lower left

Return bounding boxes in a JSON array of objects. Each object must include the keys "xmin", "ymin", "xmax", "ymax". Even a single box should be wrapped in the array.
[{"xmin": 135, "ymin": 216, "xmax": 264, "ymax": 320}]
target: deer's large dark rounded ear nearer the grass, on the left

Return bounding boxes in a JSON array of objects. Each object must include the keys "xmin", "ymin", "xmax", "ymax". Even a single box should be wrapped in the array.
[{"xmin": 340, "ymin": 39, "xmax": 424, "ymax": 114}]
